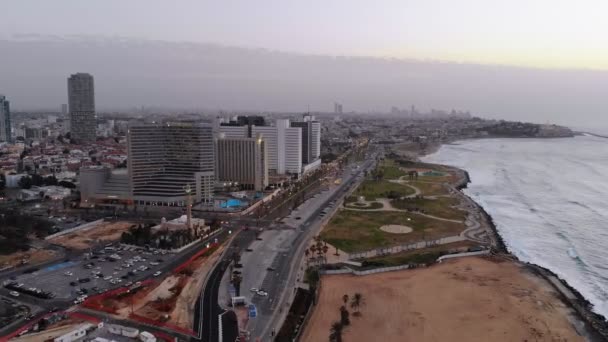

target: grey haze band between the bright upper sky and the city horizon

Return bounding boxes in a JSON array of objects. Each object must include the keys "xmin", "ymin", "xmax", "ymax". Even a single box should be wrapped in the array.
[{"xmin": 0, "ymin": 37, "xmax": 608, "ymax": 127}]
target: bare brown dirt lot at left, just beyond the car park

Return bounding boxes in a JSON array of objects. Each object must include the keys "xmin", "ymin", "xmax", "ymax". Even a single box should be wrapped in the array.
[{"xmin": 49, "ymin": 222, "xmax": 133, "ymax": 250}]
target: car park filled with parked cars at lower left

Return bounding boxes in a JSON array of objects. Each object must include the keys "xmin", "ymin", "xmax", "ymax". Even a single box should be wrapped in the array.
[{"xmin": 10, "ymin": 245, "xmax": 175, "ymax": 300}]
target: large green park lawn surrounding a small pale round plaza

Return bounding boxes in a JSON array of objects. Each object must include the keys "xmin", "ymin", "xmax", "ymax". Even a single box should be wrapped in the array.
[{"xmin": 321, "ymin": 209, "xmax": 465, "ymax": 253}]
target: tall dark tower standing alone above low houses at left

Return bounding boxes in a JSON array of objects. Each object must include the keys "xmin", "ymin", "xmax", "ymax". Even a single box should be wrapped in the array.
[{"xmin": 68, "ymin": 73, "xmax": 97, "ymax": 143}]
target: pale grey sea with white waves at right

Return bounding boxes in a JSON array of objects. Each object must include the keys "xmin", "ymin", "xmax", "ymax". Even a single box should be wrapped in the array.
[{"xmin": 422, "ymin": 135, "xmax": 608, "ymax": 317}]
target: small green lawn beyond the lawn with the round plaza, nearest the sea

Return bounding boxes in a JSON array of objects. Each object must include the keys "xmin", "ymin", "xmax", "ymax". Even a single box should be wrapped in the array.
[{"xmin": 391, "ymin": 197, "xmax": 466, "ymax": 221}]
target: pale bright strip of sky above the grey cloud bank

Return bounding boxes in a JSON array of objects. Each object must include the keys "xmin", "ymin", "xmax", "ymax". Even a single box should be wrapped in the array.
[{"xmin": 0, "ymin": 0, "xmax": 608, "ymax": 70}]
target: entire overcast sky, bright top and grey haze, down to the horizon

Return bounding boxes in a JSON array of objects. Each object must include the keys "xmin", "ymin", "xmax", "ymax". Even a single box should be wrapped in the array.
[{"xmin": 0, "ymin": 0, "xmax": 608, "ymax": 126}]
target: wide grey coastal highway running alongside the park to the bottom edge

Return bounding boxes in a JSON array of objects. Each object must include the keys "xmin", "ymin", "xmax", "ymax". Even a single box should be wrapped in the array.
[{"xmin": 202, "ymin": 150, "xmax": 375, "ymax": 342}]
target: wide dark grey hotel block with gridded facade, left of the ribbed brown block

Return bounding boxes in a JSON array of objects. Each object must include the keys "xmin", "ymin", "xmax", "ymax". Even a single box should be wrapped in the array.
[{"xmin": 127, "ymin": 122, "xmax": 215, "ymax": 206}]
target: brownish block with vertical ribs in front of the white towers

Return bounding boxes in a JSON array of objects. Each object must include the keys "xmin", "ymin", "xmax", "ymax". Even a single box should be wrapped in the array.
[{"xmin": 215, "ymin": 133, "xmax": 268, "ymax": 191}]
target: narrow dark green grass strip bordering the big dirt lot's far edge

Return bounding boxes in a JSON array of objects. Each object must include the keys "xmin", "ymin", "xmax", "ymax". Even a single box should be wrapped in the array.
[{"xmin": 363, "ymin": 241, "xmax": 478, "ymax": 267}]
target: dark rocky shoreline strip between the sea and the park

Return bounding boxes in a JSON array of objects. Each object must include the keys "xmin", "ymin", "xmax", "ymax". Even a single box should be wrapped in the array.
[{"xmin": 416, "ymin": 142, "xmax": 608, "ymax": 341}]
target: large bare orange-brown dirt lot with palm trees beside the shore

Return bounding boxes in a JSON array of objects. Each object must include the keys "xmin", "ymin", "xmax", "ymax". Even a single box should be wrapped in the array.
[{"xmin": 302, "ymin": 258, "xmax": 584, "ymax": 342}]
